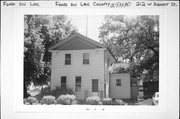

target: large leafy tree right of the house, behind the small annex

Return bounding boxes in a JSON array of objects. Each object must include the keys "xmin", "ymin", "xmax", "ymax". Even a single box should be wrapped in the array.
[{"xmin": 99, "ymin": 15, "xmax": 159, "ymax": 80}]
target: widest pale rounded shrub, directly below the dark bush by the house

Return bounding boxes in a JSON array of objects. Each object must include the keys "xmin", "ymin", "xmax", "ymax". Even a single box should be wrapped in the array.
[{"xmin": 57, "ymin": 94, "xmax": 76, "ymax": 105}]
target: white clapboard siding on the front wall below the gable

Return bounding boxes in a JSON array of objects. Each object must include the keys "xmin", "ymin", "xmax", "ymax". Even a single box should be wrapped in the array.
[{"xmin": 51, "ymin": 49, "xmax": 104, "ymax": 98}]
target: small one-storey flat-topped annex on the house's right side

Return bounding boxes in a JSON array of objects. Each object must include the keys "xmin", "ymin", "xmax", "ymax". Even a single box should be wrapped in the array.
[{"xmin": 110, "ymin": 62, "xmax": 138, "ymax": 100}]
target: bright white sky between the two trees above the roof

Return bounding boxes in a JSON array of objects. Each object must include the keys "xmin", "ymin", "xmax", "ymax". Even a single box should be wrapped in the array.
[{"xmin": 67, "ymin": 15, "xmax": 104, "ymax": 42}]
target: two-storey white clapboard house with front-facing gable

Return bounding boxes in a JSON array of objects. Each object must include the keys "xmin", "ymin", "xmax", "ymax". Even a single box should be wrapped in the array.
[{"xmin": 49, "ymin": 33, "xmax": 136, "ymax": 99}]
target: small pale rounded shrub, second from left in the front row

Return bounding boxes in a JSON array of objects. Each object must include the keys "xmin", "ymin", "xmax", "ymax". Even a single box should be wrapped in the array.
[{"xmin": 41, "ymin": 95, "xmax": 56, "ymax": 105}]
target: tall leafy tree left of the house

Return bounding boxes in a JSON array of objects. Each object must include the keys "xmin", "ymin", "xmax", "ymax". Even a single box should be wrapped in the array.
[{"xmin": 24, "ymin": 15, "xmax": 76, "ymax": 98}]
